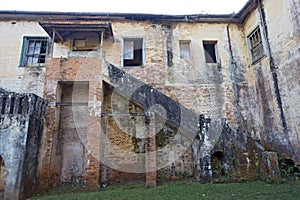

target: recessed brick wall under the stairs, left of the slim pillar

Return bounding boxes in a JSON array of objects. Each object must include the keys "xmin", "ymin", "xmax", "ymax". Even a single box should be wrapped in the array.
[{"xmin": 101, "ymin": 86, "xmax": 145, "ymax": 183}]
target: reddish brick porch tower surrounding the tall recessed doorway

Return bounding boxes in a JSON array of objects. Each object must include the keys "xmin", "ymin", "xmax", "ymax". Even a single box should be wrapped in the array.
[{"xmin": 40, "ymin": 58, "xmax": 102, "ymax": 188}]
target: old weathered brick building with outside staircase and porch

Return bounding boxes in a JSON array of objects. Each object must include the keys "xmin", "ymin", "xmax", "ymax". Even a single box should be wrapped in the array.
[{"xmin": 0, "ymin": 0, "xmax": 300, "ymax": 196}]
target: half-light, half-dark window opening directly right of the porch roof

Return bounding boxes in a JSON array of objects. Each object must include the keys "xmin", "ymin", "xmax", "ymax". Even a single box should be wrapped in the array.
[{"xmin": 123, "ymin": 38, "xmax": 144, "ymax": 67}]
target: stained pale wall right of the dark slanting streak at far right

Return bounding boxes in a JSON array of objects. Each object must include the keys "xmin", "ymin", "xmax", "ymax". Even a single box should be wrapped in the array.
[{"xmin": 264, "ymin": 0, "xmax": 300, "ymax": 165}]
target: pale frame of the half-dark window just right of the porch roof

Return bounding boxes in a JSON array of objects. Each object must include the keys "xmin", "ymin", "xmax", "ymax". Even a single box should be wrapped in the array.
[{"xmin": 121, "ymin": 36, "xmax": 146, "ymax": 68}]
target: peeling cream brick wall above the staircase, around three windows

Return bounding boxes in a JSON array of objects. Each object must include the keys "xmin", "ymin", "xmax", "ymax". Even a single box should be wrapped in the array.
[{"xmin": 103, "ymin": 21, "xmax": 239, "ymax": 124}]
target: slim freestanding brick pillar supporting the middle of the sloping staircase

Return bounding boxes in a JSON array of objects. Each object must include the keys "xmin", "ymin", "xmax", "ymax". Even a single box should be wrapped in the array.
[{"xmin": 145, "ymin": 111, "xmax": 156, "ymax": 187}]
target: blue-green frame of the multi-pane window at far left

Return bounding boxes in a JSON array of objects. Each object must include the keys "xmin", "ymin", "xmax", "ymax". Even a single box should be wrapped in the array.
[{"xmin": 19, "ymin": 36, "xmax": 49, "ymax": 67}]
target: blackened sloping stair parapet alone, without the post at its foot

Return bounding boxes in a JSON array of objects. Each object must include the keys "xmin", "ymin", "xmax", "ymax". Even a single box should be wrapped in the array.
[{"xmin": 103, "ymin": 63, "xmax": 199, "ymax": 139}]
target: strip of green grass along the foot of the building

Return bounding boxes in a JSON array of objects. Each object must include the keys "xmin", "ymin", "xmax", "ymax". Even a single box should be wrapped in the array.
[{"xmin": 30, "ymin": 181, "xmax": 300, "ymax": 200}]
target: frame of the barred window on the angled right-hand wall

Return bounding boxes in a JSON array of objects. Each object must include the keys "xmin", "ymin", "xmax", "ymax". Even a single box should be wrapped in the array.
[{"xmin": 247, "ymin": 25, "xmax": 265, "ymax": 65}]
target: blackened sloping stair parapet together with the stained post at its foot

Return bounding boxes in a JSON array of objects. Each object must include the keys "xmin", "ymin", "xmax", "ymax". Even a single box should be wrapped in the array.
[{"xmin": 102, "ymin": 63, "xmax": 232, "ymax": 180}]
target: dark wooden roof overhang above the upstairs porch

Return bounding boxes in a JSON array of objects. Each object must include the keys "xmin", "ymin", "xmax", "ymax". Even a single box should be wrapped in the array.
[{"xmin": 39, "ymin": 21, "xmax": 113, "ymax": 42}]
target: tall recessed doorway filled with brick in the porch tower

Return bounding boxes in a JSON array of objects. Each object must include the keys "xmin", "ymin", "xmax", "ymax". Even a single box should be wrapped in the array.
[{"xmin": 57, "ymin": 81, "xmax": 89, "ymax": 184}]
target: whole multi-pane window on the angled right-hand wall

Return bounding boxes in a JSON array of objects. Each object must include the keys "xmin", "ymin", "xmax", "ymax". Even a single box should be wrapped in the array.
[{"xmin": 248, "ymin": 27, "xmax": 264, "ymax": 63}]
